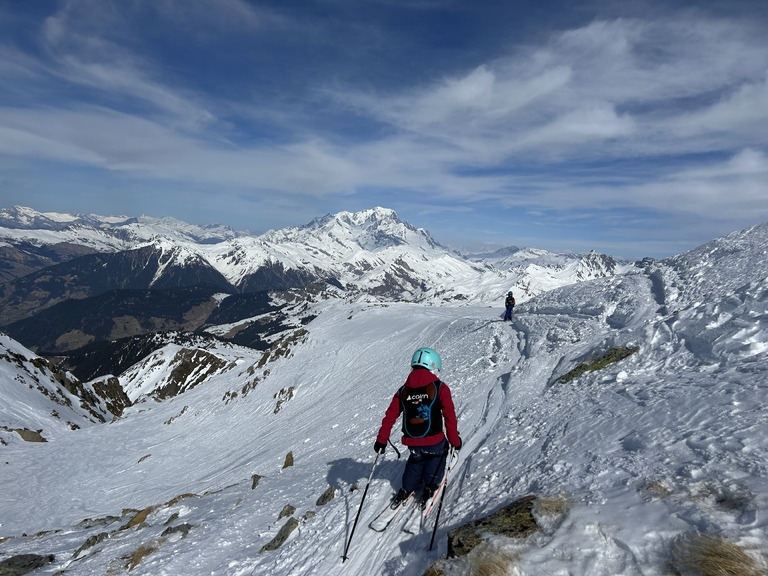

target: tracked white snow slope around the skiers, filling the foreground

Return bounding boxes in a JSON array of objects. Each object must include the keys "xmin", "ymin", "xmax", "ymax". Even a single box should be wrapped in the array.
[{"xmin": 0, "ymin": 224, "xmax": 768, "ymax": 576}]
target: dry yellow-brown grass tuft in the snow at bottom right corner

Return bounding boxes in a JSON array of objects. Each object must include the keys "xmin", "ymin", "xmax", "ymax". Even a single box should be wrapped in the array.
[{"xmin": 672, "ymin": 532, "xmax": 765, "ymax": 576}]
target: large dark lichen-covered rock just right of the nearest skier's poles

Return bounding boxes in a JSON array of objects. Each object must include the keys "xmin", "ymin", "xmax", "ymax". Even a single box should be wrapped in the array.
[{"xmin": 448, "ymin": 495, "xmax": 540, "ymax": 558}]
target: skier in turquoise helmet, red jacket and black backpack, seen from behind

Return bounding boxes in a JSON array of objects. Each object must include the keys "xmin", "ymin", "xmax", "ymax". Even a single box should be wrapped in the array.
[{"xmin": 374, "ymin": 348, "xmax": 461, "ymax": 509}]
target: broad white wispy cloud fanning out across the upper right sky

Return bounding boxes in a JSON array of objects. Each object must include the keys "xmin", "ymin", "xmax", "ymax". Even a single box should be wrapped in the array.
[{"xmin": 337, "ymin": 20, "xmax": 768, "ymax": 161}]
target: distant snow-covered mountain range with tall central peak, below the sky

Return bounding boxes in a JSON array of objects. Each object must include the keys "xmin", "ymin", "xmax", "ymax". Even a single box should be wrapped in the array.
[{"xmin": 0, "ymin": 207, "xmax": 620, "ymax": 336}]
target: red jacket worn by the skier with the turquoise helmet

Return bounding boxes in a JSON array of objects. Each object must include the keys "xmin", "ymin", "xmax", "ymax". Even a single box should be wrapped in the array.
[{"xmin": 376, "ymin": 368, "xmax": 461, "ymax": 448}]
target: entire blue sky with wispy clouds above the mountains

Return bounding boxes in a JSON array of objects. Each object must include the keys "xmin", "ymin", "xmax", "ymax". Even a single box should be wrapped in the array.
[{"xmin": 0, "ymin": 0, "xmax": 768, "ymax": 259}]
